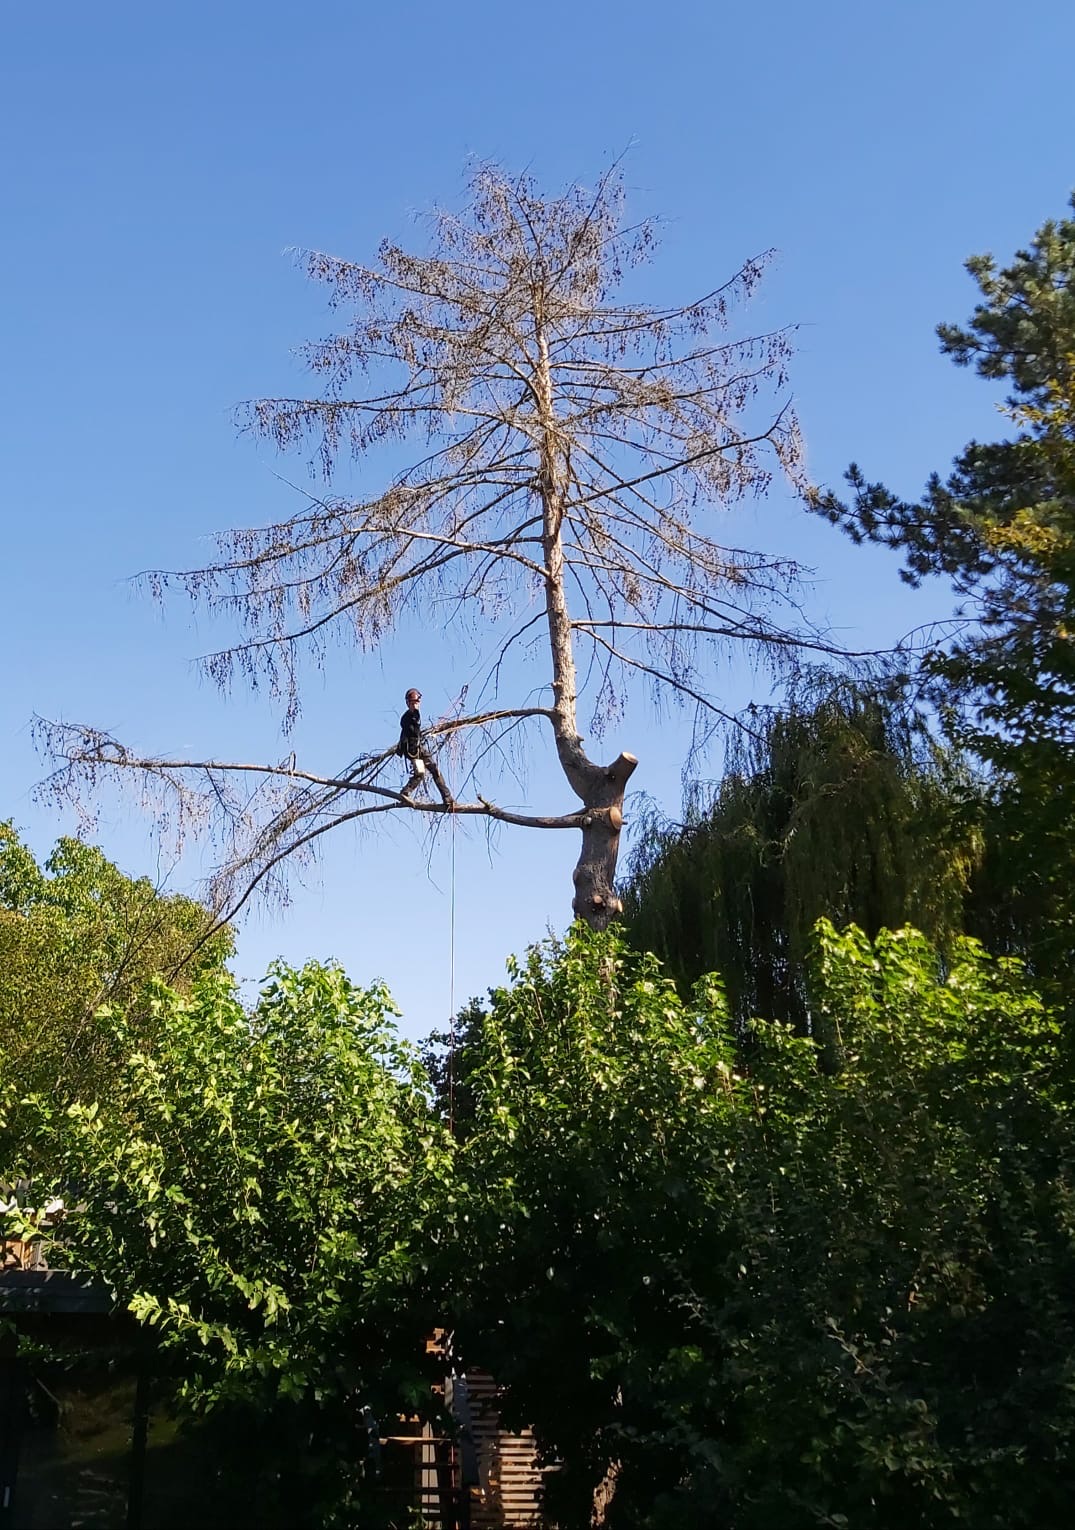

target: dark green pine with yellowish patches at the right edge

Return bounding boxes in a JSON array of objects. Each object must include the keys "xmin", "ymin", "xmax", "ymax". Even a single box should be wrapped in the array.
[{"xmin": 820, "ymin": 197, "xmax": 1075, "ymax": 996}]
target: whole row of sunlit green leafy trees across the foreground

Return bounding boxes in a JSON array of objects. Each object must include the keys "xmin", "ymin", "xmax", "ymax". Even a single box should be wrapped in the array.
[{"xmin": 11, "ymin": 899, "xmax": 1075, "ymax": 1530}]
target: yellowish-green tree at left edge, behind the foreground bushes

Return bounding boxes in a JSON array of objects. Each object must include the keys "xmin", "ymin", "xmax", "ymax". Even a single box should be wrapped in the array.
[{"xmin": 0, "ymin": 823, "xmax": 231, "ymax": 1132}]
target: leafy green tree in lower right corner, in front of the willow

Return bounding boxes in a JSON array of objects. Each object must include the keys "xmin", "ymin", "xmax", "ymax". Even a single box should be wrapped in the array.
[{"xmin": 714, "ymin": 923, "xmax": 1075, "ymax": 1530}]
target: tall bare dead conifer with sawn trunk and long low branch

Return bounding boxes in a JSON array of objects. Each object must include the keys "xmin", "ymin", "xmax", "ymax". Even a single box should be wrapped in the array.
[{"xmin": 40, "ymin": 168, "xmax": 820, "ymax": 927}]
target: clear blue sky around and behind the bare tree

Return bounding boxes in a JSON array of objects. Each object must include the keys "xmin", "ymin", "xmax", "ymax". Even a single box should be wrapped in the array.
[{"xmin": 0, "ymin": 0, "xmax": 1075, "ymax": 1033}]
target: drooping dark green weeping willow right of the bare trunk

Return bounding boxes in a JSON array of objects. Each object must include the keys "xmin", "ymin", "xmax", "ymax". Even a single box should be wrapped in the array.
[{"xmin": 624, "ymin": 675, "xmax": 983, "ymax": 1030}]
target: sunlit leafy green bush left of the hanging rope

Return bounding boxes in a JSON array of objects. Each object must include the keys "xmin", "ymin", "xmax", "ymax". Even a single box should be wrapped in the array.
[{"xmin": 22, "ymin": 964, "xmax": 450, "ymax": 1524}]
